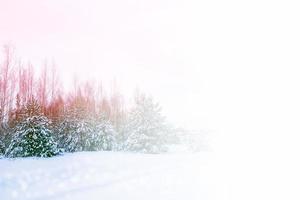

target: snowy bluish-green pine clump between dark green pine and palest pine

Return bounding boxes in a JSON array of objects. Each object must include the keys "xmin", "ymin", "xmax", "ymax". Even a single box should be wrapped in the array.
[{"xmin": 58, "ymin": 110, "xmax": 116, "ymax": 152}]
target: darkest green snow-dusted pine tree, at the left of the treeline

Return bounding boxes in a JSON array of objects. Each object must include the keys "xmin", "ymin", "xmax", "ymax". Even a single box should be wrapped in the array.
[{"xmin": 5, "ymin": 100, "xmax": 59, "ymax": 157}]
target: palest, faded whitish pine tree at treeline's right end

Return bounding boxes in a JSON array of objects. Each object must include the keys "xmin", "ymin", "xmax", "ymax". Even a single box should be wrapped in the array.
[{"xmin": 124, "ymin": 95, "xmax": 167, "ymax": 153}]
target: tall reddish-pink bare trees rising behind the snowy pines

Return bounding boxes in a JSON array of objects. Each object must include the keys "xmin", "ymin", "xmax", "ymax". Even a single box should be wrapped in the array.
[{"xmin": 0, "ymin": 46, "xmax": 125, "ymax": 128}]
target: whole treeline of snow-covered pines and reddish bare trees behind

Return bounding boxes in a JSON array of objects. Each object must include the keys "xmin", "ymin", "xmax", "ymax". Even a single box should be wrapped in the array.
[{"xmin": 0, "ymin": 46, "xmax": 176, "ymax": 157}]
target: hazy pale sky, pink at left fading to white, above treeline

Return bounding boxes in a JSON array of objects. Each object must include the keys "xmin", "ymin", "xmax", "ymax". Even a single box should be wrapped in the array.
[{"xmin": 0, "ymin": 0, "xmax": 300, "ymax": 149}]
